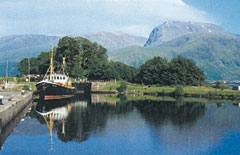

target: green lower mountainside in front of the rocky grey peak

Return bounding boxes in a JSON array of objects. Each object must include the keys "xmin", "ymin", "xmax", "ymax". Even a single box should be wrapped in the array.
[{"xmin": 109, "ymin": 33, "xmax": 240, "ymax": 80}]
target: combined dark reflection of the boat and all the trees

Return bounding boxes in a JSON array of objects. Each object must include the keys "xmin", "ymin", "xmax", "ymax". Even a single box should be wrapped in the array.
[{"xmin": 33, "ymin": 96, "xmax": 206, "ymax": 148}]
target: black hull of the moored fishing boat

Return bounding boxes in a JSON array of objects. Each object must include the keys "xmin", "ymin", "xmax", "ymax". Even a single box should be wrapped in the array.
[{"xmin": 36, "ymin": 82, "xmax": 76, "ymax": 100}]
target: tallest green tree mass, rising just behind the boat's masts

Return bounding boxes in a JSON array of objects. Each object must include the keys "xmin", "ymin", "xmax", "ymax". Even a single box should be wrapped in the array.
[{"xmin": 55, "ymin": 36, "xmax": 108, "ymax": 78}]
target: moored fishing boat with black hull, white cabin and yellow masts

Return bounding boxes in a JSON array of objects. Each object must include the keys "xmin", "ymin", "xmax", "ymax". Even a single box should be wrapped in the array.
[{"xmin": 36, "ymin": 49, "xmax": 76, "ymax": 100}]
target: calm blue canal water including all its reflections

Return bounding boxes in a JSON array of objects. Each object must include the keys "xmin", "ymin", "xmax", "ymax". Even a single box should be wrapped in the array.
[{"xmin": 0, "ymin": 96, "xmax": 240, "ymax": 155}]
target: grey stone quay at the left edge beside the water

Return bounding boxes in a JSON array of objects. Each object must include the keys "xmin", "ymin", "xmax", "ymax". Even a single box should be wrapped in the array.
[{"xmin": 0, "ymin": 92, "xmax": 33, "ymax": 133}]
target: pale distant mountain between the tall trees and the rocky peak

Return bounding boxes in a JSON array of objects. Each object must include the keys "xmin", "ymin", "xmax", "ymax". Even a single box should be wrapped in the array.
[{"xmin": 83, "ymin": 32, "xmax": 147, "ymax": 52}]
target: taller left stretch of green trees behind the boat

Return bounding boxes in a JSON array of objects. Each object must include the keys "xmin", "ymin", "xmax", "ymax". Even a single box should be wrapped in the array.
[{"xmin": 18, "ymin": 36, "xmax": 136, "ymax": 81}]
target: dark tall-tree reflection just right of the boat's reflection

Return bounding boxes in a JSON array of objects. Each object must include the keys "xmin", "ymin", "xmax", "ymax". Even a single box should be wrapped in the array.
[{"xmin": 57, "ymin": 103, "xmax": 108, "ymax": 143}]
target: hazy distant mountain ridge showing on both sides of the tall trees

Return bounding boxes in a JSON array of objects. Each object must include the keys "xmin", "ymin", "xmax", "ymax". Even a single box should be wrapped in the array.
[{"xmin": 0, "ymin": 32, "xmax": 147, "ymax": 62}]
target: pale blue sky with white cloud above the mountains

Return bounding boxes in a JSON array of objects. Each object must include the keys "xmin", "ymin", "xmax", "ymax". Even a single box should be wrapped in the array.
[{"xmin": 0, "ymin": 0, "xmax": 240, "ymax": 37}]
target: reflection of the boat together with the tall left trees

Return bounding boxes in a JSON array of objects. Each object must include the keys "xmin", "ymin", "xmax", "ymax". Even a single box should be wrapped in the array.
[{"xmin": 32, "ymin": 94, "xmax": 133, "ymax": 148}]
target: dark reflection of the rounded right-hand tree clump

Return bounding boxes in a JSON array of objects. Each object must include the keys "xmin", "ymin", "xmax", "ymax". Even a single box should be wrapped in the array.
[{"xmin": 135, "ymin": 98, "xmax": 206, "ymax": 127}]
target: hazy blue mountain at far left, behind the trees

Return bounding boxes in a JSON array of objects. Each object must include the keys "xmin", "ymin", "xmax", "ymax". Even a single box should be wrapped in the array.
[{"xmin": 0, "ymin": 35, "xmax": 60, "ymax": 62}]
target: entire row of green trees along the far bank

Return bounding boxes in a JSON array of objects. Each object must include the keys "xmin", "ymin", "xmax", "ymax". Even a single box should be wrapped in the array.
[{"xmin": 18, "ymin": 36, "xmax": 205, "ymax": 85}]
